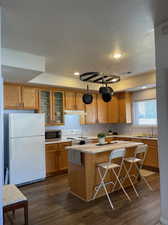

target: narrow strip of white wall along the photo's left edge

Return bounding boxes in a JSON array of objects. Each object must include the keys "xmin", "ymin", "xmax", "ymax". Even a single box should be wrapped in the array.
[{"xmin": 0, "ymin": 9, "xmax": 3, "ymax": 225}]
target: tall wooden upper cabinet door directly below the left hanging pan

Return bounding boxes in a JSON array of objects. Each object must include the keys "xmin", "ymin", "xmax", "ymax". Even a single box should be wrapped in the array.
[{"xmin": 85, "ymin": 94, "xmax": 97, "ymax": 124}]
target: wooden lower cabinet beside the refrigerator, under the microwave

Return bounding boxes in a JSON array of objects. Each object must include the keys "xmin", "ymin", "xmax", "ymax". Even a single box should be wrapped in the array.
[{"xmin": 46, "ymin": 142, "xmax": 71, "ymax": 177}]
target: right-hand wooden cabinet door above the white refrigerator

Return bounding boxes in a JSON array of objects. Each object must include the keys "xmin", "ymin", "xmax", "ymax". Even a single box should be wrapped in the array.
[{"xmin": 22, "ymin": 86, "xmax": 38, "ymax": 109}]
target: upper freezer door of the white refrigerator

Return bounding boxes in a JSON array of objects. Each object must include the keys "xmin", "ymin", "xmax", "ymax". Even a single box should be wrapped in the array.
[{"xmin": 9, "ymin": 113, "xmax": 45, "ymax": 138}]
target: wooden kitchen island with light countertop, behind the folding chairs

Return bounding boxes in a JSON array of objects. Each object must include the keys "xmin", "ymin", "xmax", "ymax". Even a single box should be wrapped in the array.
[{"xmin": 66, "ymin": 141, "xmax": 142, "ymax": 201}]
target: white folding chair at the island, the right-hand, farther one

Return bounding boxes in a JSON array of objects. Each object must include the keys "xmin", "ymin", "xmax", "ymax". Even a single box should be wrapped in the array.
[{"xmin": 122, "ymin": 145, "xmax": 152, "ymax": 197}]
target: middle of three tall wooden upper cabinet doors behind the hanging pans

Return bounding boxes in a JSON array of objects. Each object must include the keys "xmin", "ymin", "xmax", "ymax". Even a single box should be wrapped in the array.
[{"xmin": 97, "ymin": 95, "xmax": 108, "ymax": 123}]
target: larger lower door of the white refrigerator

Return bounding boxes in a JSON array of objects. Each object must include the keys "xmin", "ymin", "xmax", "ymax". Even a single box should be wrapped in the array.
[{"xmin": 9, "ymin": 136, "xmax": 45, "ymax": 184}]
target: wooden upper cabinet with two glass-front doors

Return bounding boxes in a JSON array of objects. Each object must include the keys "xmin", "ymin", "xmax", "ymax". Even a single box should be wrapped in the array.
[{"xmin": 39, "ymin": 89, "xmax": 64, "ymax": 126}]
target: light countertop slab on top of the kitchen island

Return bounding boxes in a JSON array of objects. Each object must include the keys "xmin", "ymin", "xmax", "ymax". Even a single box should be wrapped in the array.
[{"xmin": 66, "ymin": 141, "xmax": 143, "ymax": 154}]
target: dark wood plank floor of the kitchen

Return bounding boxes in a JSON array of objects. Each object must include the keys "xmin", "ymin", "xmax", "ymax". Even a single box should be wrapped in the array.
[{"xmin": 6, "ymin": 175, "xmax": 160, "ymax": 225}]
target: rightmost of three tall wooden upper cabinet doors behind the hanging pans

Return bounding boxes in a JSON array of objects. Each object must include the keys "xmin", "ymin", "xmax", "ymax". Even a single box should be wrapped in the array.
[{"xmin": 107, "ymin": 95, "xmax": 119, "ymax": 123}]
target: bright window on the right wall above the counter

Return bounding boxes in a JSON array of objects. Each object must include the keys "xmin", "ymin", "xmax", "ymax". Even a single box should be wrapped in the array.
[{"xmin": 133, "ymin": 99, "xmax": 157, "ymax": 125}]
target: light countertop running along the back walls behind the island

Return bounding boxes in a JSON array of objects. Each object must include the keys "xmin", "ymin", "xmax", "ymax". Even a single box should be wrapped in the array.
[{"xmin": 45, "ymin": 134, "xmax": 158, "ymax": 144}]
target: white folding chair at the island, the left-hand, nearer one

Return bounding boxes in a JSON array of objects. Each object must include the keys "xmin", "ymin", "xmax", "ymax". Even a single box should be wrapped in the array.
[{"xmin": 93, "ymin": 149, "xmax": 131, "ymax": 209}]
